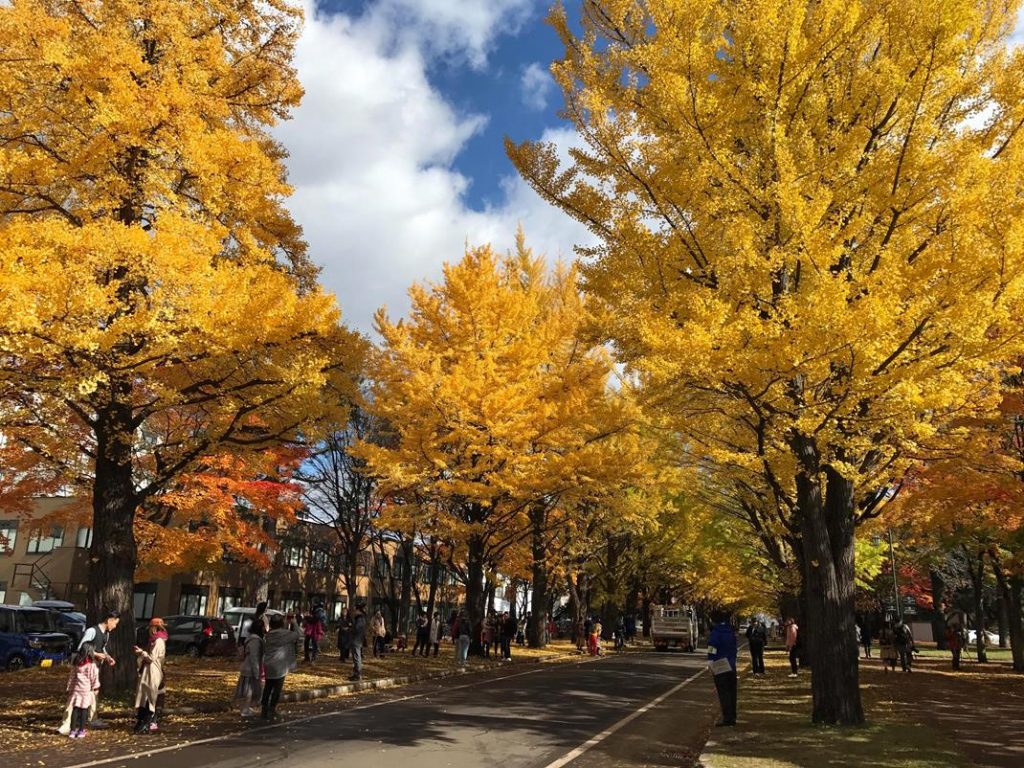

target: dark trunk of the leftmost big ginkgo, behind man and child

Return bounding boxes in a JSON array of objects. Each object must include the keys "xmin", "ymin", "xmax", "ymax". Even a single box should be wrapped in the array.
[{"xmin": 86, "ymin": 397, "xmax": 138, "ymax": 694}]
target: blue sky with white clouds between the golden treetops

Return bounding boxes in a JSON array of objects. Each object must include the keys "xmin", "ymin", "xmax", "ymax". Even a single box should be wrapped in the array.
[{"xmin": 275, "ymin": 0, "xmax": 1021, "ymax": 333}]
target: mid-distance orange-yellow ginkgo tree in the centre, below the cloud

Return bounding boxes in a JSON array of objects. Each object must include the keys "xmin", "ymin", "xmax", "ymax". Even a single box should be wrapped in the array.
[{"xmin": 361, "ymin": 232, "xmax": 633, "ymax": 647}]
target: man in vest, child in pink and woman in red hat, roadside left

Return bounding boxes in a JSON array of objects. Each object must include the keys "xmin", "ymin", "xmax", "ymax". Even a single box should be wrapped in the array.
[{"xmin": 57, "ymin": 610, "xmax": 167, "ymax": 738}]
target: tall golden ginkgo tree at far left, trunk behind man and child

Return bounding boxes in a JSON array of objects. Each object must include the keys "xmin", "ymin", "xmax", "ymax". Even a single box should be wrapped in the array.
[{"xmin": 0, "ymin": 0, "xmax": 362, "ymax": 687}]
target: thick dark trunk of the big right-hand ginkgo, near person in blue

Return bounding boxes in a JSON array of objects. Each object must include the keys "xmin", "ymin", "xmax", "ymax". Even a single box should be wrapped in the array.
[{"xmin": 794, "ymin": 436, "xmax": 864, "ymax": 725}]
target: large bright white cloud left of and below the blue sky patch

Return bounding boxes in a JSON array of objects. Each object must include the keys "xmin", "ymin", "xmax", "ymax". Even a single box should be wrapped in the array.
[{"xmin": 276, "ymin": 0, "xmax": 592, "ymax": 331}]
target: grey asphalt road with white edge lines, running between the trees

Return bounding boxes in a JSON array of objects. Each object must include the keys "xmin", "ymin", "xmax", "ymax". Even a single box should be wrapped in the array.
[{"xmin": 68, "ymin": 653, "xmax": 717, "ymax": 768}]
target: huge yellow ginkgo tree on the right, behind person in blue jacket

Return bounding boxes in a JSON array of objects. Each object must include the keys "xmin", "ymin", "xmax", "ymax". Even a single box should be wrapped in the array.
[{"xmin": 508, "ymin": 0, "xmax": 1024, "ymax": 724}]
